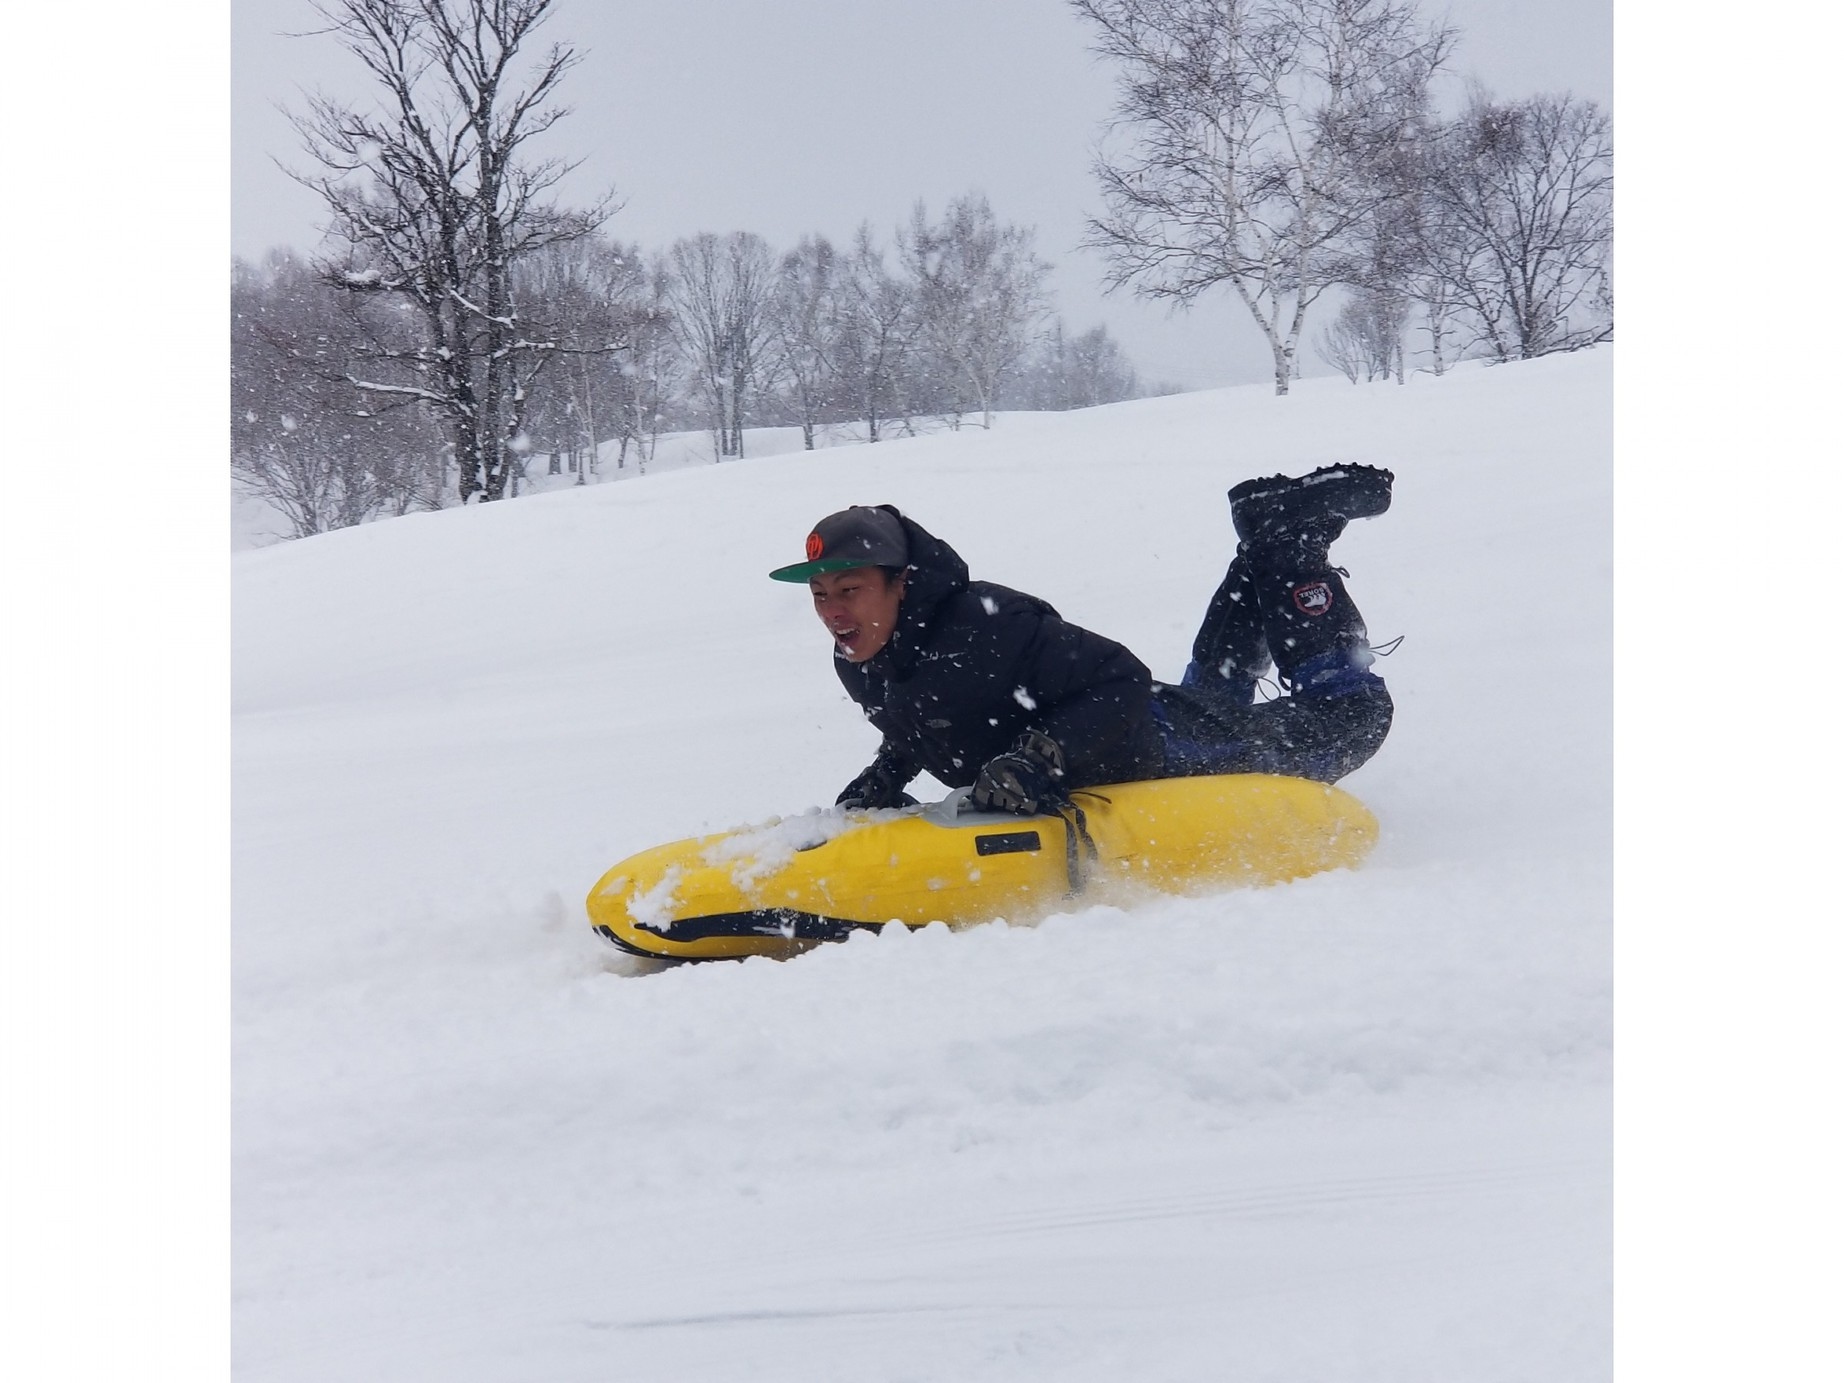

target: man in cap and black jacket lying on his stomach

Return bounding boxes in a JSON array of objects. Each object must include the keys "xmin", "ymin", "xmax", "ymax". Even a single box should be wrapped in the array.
[{"xmin": 769, "ymin": 465, "xmax": 1394, "ymax": 815}]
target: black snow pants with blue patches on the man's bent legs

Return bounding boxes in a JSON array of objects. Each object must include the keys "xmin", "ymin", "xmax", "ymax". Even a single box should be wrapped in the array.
[{"xmin": 1153, "ymin": 540, "xmax": 1394, "ymax": 782}]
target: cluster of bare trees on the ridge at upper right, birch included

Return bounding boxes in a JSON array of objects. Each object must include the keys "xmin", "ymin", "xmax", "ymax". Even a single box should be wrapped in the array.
[{"xmin": 1071, "ymin": 0, "xmax": 1614, "ymax": 393}]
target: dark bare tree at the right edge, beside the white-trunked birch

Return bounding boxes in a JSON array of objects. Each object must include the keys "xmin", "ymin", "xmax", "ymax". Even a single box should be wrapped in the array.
[{"xmin": 1422, "ymin": 90, "xmax": 1614, "ymax": 360}]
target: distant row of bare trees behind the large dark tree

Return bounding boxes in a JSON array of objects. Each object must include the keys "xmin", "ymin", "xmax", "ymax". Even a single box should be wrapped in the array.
[{"xmin": 231, "ymin": 194, "xmax": 1143, "ymax": 535}]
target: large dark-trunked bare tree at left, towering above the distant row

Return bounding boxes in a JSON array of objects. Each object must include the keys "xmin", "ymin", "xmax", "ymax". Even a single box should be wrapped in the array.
[{"xmin": 283, "ymin": 0, "xmax": 612, "ymax": 503}]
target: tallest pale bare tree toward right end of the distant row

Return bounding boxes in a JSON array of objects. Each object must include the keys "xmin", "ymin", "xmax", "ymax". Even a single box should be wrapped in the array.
[{"xmin": 900, "ymin": 192, "xmax": 1049, "ymax": 428}]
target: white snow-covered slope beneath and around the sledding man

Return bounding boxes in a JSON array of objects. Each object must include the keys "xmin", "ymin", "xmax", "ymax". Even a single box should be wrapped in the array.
[{"xmin": 232, "ymin": 349, "xmax": 1612, "ymax": 1383}]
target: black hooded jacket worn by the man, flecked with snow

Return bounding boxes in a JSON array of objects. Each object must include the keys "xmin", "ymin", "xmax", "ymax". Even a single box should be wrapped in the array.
[{"xmin": 833, "ymin": 505, "xmax": 1164, "ymax": 787}]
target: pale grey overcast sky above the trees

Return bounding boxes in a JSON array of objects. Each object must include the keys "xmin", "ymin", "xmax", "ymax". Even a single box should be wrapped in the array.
[{"xmin": 231, "ymin": 0, "xmax": 1614, "ymax": 387}]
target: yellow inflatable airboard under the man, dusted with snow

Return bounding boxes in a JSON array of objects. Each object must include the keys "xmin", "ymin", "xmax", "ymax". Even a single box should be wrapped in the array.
[{"xmin": 588, "ymin": 773, "xmax": 1377, "ymax": 959}]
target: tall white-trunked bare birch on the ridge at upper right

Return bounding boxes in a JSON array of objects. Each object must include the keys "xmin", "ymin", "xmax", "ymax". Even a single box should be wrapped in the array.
[{"xmin": 1071, "ymin": 0, "xmax": 1453, "ymax": 395}]
